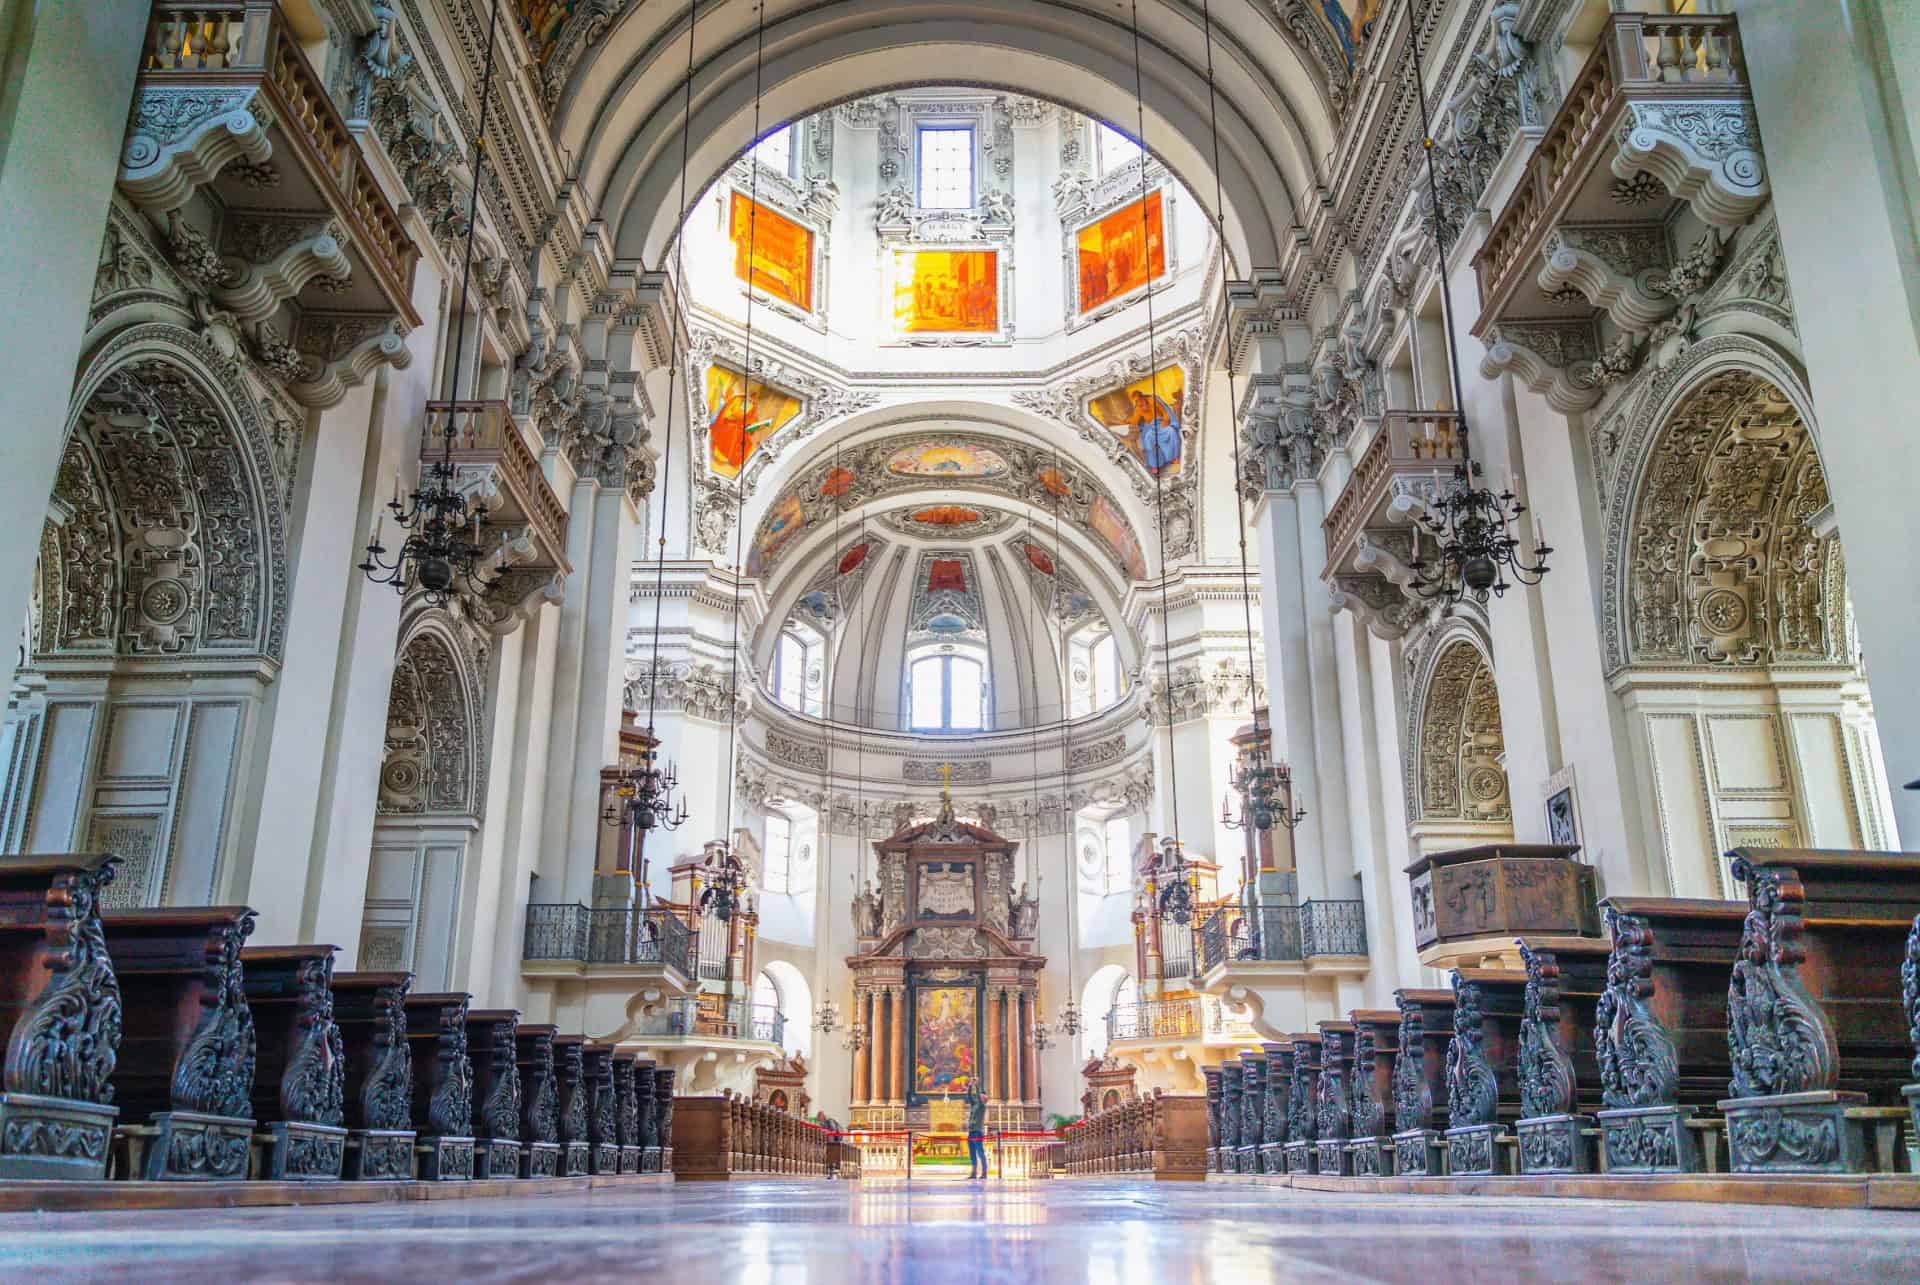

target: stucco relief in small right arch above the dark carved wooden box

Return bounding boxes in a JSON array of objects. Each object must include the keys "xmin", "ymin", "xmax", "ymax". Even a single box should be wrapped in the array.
[{"xmin": 1419, "ymin": 640, "xmax": 1513, "ymax": 822}]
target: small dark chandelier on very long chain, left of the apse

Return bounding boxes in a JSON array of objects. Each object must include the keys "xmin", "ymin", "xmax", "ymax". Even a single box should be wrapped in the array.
[{"xmin": 601, "ymin": 6, "xmax": 699, "ymax": 860}]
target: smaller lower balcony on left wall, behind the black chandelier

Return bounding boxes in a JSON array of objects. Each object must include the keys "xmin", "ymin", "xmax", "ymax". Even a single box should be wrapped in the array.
[{"xmin": 435, "ymin": 401, "xmax": 572, "ymax": 574}]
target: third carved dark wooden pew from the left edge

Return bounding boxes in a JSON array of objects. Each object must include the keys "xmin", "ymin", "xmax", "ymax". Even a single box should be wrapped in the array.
[{"xmin": 240, "ymin": 945, "xmax": 348, "ymax": 1179}]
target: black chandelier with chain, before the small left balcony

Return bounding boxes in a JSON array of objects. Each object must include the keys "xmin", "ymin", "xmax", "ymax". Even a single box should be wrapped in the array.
[{"xmin": 357, "ymin": 0, "xmax": 499, "ymax": 607}]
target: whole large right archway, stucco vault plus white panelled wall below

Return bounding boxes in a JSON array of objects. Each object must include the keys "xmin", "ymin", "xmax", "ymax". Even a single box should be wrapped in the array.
[{"xmin": 1609, "ymin": 365, "xmax": 1891, "ymax": 897}]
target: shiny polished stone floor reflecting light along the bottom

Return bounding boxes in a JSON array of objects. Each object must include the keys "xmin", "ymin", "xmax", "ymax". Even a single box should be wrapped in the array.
[{"xmin": 0, "ymin": 1179, "xmax": 1920, "ymax": 1285}]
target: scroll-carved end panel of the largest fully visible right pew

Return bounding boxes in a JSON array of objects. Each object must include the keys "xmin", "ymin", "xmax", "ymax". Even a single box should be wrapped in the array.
[{"xmin": 1726, "ymin": 849, "xmax": 1839, "ymax": 1097}]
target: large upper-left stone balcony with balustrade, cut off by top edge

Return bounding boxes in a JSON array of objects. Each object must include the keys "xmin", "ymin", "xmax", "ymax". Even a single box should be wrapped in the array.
[{"xmin": 119, "ymin": 0, "xmax": 420, "ymax": 353}]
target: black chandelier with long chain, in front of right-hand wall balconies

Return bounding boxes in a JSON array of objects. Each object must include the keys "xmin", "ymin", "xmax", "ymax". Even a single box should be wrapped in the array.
[{"xmin": 1407, "ymin": 6, "xmax": 1553, "ymax": 611}]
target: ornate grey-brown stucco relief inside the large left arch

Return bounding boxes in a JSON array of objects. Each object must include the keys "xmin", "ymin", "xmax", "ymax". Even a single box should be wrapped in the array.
[{"xmin": 35, "ymin": 357, "xmax": 286, "ymax": 657}]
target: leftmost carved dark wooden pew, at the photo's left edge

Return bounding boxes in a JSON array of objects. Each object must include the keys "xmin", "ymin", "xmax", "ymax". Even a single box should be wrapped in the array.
[{"xmin": 0, "ymin": 853, "xmax": 121, "ymax": 1179}]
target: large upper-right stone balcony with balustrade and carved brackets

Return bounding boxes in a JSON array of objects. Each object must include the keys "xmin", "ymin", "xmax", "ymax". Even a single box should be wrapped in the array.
[{"xmin": 1473, "ymin": 13, "xmax": 1766, "ymax": 395}]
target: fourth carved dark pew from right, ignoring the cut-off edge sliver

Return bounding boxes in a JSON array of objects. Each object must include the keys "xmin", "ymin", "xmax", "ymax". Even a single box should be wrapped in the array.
[{"xmin": 1446, "ymin": 968, "xmax": 1526, "ymax": 1174}]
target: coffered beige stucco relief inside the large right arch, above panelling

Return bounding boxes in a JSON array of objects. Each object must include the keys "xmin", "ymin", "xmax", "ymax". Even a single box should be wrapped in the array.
[{"xmin": 1624, "ymin": 371, "xmax": 1845, "ymax": 667}]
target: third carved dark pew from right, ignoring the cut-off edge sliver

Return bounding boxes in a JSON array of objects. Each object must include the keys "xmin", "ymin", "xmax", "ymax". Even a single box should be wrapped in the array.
[{"xmin": 1513, "ymin": 937, "xmax": 1609, "ymax": 1174}]
